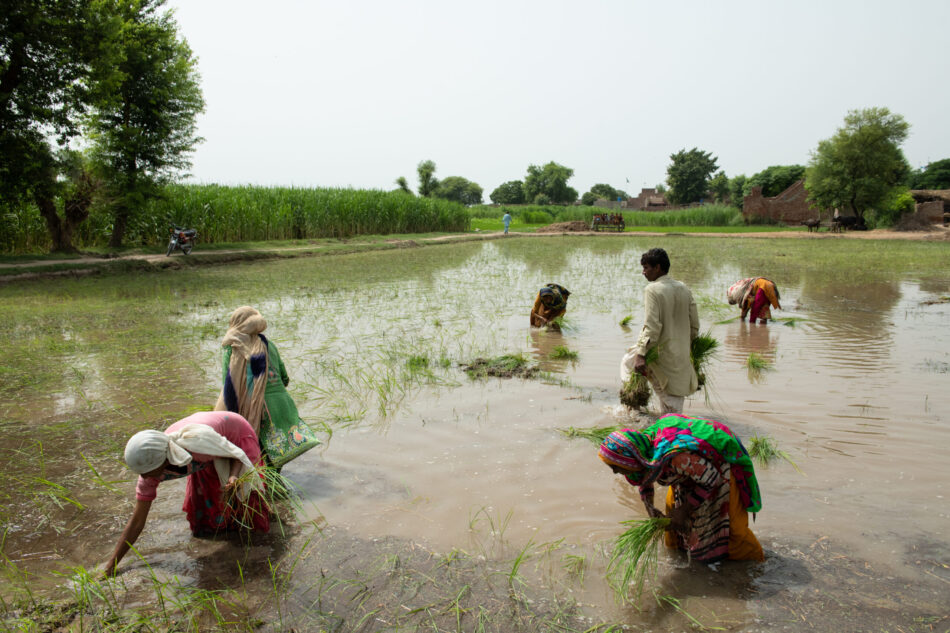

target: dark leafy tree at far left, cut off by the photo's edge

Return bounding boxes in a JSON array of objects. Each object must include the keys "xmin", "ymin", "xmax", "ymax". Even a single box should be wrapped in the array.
[{"xmin": 0, "ymin": 0, "xmax": 114, "ymax": 252}]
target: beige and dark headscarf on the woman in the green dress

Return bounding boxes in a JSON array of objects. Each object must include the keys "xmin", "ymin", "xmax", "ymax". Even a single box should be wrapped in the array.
[{"xmin": 221, "ymin": 306, "xmax": 267, "ymax": 433}]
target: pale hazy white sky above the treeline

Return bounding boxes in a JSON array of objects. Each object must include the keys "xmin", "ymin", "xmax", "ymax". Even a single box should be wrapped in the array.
[{"xmin": 168, "ymin": 0, "xmax": 950, "ymax": 202}]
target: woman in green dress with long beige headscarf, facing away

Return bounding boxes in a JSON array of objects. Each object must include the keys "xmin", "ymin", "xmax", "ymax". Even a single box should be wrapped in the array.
[{"xmin": 214, "ymin": 306, "xmax": 320, "ymax": 468}]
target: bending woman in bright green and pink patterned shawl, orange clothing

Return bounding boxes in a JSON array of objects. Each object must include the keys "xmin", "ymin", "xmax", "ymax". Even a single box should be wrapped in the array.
[{"xmin": 599, "ymin": 414, "xmax": 765, "ymax": 563}]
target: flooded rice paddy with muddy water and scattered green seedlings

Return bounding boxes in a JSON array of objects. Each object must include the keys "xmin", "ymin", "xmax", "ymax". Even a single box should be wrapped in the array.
[{"xmin": 0, "ymin": 236, "xmax": 950, "ymax": 631}]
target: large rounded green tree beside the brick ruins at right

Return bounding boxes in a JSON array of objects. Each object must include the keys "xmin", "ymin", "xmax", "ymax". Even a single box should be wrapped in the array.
[{"xmin": 805, "ymin": 108, "xmax": 910, "ymax": 220}]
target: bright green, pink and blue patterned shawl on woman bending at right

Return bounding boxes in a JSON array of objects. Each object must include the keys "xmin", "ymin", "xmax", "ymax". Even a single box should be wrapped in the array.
[{"xmin": 598, "ymin": 413, "xmax": 762, "ymax": 512}]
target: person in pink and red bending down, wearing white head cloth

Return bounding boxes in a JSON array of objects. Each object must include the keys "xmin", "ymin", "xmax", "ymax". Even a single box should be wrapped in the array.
[{"xmin": 105, "ymin": 411, "xmax": 270, "ymax": 575}]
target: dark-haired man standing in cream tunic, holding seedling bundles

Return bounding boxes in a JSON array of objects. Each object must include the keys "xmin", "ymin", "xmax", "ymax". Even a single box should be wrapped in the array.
[{"xmin": 620, "ymin": 248, "xmax": 699, "ymax": 414}]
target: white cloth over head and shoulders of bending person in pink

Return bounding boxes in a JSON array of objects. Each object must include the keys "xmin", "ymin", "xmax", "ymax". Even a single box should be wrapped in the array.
[{"xmin": 125, "ymin": 424, "xmax": 260, "ymax": 499}]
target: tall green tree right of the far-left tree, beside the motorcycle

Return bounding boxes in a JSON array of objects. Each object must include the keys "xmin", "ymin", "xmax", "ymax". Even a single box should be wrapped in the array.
[{"xmin": 88, "ymin": 0, "xmax": 204, "ymax": 247}]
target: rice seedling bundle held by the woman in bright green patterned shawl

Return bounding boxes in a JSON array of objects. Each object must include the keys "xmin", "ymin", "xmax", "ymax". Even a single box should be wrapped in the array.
[{"xmin": 607, "ymin": 517, "xmax": 670, "ymax": 600}]
